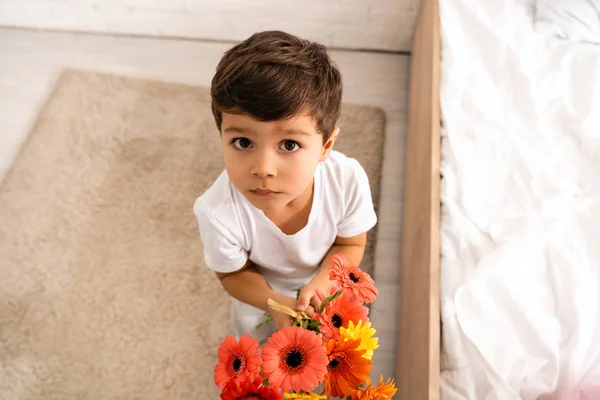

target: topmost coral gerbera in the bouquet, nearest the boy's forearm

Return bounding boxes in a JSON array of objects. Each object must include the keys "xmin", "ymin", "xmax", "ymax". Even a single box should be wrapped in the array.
[{"xmin": 329, "ymin": 253, "xmax": 377, "ymax": 303}]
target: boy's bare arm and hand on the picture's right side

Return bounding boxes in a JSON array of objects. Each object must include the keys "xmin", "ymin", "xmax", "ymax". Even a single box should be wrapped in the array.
[{"xmin": 296, "ymin": 232, "xmax": 367, "ymax": 316}]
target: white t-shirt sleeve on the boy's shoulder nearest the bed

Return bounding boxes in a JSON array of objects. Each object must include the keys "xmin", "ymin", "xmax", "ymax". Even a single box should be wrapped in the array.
[{"xmin": 338, "ymin": 159, "xmax": 377, "ymax": 237}]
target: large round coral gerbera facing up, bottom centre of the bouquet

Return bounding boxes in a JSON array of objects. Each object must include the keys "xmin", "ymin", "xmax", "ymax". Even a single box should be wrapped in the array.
[{"xmin": 262, "ymin": 326, "xmax": 328, "ymax": 392}]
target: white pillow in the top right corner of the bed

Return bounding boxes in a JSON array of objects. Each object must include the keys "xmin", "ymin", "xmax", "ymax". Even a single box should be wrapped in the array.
[{"xmin": 535, "ymin": 0, "xmax": 600, "ymax": 45}]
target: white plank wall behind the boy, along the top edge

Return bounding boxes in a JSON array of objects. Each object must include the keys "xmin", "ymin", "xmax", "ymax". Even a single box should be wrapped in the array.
[{"xmin": 0, "ymin": 0, "xmax": 419, "ymax": 51}]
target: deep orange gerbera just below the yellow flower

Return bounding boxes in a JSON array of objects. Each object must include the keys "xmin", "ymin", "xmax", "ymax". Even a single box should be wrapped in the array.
[{"xmin": 325, "ymin": 339, "xmax": 373, "ymax": 398}]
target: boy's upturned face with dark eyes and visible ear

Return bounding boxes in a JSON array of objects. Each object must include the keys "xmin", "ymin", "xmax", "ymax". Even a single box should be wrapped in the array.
[{"xmin": 221, "ymin": 113, "xmax": 339, "ymax": 212}]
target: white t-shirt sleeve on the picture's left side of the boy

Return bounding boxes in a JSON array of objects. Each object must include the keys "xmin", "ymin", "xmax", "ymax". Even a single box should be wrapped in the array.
[{"xmin": 194, "ymin": 202, "xmax": 248, "ymax": 273}]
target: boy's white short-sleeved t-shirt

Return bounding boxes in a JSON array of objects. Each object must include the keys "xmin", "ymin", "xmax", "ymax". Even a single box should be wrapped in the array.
[{"xmin": 194, "ymin": 151, "xmax": 377, "ymax": 297}]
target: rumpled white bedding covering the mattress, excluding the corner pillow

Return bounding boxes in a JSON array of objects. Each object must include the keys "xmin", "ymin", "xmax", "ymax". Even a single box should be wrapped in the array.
[{"xmin": 440, "ymin": 0, "xmax": 600, "ymax": 400}]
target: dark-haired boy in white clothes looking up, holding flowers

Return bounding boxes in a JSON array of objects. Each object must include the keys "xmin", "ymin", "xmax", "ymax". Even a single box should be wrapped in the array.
[{"xmin": 194, "ymin": 31, "xmax": 377, "ymax": 341}]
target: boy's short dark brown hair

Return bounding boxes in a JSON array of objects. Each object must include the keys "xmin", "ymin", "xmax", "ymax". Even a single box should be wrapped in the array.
[{"xmin": 211, "ymin": 31, "xmax": 342, "ymax": 143}]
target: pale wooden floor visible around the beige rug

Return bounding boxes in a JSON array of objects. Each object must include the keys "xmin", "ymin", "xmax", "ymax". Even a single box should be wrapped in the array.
[{"xmin": 0, "ymin": 28, "xmax": 409, "ymax": 379}]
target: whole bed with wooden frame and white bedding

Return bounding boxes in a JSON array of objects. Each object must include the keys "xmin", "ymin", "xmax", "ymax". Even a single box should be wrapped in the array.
[{"xmin": 397, "ymin": 0, "xmax": 600, "ymax": 400}]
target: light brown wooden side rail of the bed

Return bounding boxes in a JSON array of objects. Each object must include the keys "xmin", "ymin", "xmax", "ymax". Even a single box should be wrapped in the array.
[{"xmin": 396, "ymin": 0, "xmax": 441, "ymax": 400}]
